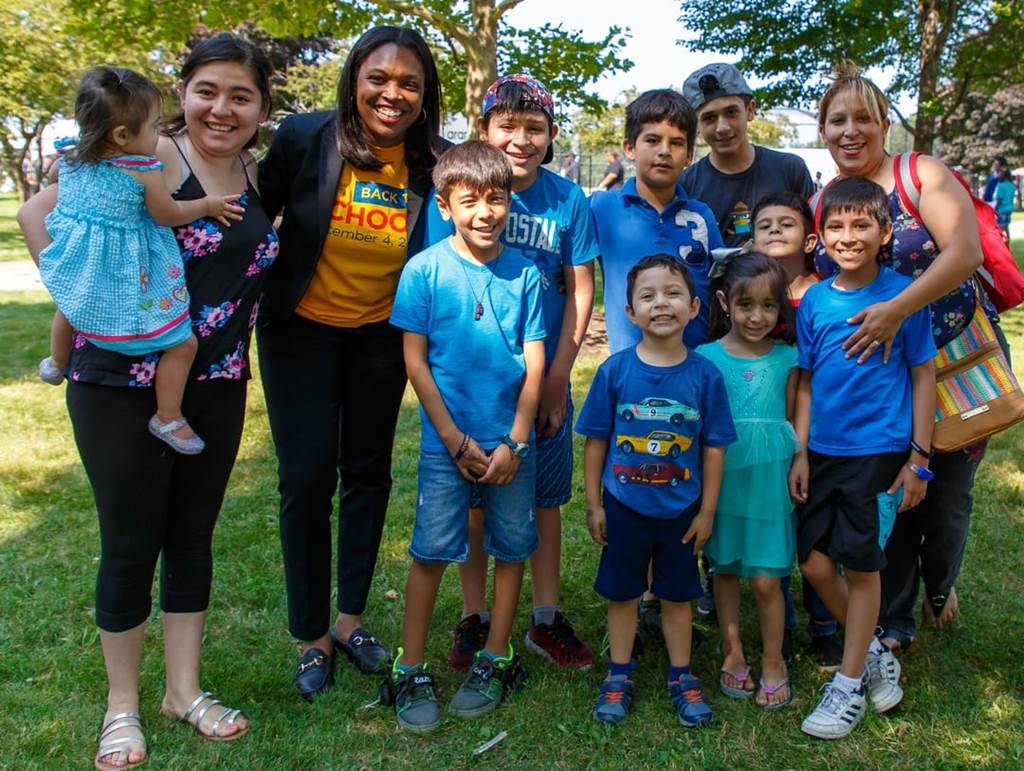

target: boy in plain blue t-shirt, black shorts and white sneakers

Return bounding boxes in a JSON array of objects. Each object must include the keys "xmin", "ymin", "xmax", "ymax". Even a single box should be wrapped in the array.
[{"xmin": 790, "ymin": 177, "xmax": 935, "ymax": 739}]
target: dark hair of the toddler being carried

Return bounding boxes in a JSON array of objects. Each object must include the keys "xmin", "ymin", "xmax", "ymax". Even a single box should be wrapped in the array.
[{"xmin": 68, "ymin": 66, "xmax": 163, "ymax": 164}]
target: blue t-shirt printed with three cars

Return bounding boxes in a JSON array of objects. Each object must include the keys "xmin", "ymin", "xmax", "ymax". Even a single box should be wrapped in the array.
[{"xmin": 577, "ymin": 347, "xmax": 736, "ymax": 519}]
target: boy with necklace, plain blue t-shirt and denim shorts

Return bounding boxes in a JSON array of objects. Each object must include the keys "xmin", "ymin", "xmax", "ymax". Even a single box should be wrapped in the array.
[{"xmin": 384, "ymin": 141, "xmax": 545, "ymax": 731}]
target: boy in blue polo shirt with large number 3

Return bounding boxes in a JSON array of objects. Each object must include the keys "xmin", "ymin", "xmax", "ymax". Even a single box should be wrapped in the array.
[{"xmin": 590, "ymin": 88, "xmax": 722, "ymax": 353}]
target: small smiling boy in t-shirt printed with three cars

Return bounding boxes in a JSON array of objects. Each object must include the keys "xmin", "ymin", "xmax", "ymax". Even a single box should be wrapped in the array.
[{"xmin": 577, "ymin": 255, "xmax": 736, "ymax": 726}]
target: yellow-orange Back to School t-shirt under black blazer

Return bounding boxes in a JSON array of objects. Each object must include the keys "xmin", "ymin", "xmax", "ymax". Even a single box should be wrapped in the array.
[{"xmin": 295, "ymin": 144, "xmax": 409, "ymax": 327}]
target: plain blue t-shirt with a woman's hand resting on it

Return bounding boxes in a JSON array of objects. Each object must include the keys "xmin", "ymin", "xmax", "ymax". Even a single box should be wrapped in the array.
[{"xmin": 797, "ymin": 267, "xmax": 935, "ymax": 456}]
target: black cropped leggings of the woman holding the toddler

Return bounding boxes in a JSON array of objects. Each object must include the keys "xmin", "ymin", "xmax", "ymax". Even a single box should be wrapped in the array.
[{"xmin": 67, "ymin": 381, "xmax": 246, "ymax": 632}]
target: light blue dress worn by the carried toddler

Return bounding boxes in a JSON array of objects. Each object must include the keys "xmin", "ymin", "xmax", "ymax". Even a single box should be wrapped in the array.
[{"xmin": 39, "ymin": 146, "xmax": 191, "ymax": 355}]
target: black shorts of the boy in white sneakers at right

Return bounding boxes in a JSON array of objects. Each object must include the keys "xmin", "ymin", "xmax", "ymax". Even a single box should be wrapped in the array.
[{"xmin": 797, "ymin": 451, "xmax": 907, "ymax": 572}]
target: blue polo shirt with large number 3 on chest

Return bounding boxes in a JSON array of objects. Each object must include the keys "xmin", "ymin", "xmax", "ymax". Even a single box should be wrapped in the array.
[{"xmin": 590, "ymin": 177, "xmax": 722, "ymax": 353}]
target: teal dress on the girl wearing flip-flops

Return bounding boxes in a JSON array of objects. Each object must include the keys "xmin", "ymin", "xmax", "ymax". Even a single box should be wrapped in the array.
[{"xmin": 697, "ymin": 341, "xmax": 800, "ymax": 576}]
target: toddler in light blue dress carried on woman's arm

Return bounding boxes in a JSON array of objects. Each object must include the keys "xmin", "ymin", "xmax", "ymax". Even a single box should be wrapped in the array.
[{"xmin": 32, "ymin": 67, "xmax": 243, "ymax": 455}]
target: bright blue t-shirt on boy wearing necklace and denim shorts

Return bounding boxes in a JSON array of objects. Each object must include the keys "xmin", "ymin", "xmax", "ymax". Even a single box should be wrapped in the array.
[{"xmin": 391, "ymin": 240, "xmax": 544, "ymax": 453}]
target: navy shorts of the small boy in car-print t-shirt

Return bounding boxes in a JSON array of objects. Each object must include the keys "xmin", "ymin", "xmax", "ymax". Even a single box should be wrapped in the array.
[{"xmin": 594, "ymin": 492, "xmax": 702, "ymax": 602}]
